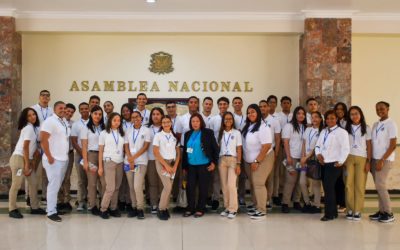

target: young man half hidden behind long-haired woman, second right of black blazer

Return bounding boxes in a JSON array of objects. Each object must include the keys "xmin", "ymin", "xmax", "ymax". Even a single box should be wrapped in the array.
[{"xmin": 259, "ymin": 100, "xmax": 282, "ymax": 209}]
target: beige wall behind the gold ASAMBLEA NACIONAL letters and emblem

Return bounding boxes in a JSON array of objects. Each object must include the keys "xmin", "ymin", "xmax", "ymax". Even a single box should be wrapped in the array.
[{"xmin": 22, "ymin": 33, "xmax": 299, "ymax": 116}]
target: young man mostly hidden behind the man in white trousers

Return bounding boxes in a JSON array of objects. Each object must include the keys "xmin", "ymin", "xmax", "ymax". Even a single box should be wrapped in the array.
[{"xmin": 57, "ymin": 103, "xmax": 76, "ymax": 212}]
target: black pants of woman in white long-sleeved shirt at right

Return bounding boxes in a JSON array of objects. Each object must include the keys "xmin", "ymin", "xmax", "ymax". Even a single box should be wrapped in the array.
[{"xmin": 322, "ymin": 163, "xmax": 342, "ymax": 218}]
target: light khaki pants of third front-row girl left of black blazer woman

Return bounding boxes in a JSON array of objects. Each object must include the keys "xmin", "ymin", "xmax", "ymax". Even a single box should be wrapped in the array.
[{"xmin": 101, "ymin": 161, "xmax": 124, "ymax": 212}]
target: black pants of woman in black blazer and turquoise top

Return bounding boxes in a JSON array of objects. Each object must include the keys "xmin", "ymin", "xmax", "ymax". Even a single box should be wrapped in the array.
[{"xmin": 186, "ymin": 164, "xmax": 211, "ymax": 213}]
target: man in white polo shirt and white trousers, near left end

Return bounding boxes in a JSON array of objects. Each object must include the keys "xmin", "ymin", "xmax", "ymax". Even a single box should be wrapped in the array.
[{"xmin": 40, "ymin": 101, "xmax": 71, "ymax": 222}]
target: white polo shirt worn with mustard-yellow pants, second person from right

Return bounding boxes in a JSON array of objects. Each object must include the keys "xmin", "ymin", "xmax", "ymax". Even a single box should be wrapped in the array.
[{"xmin": 349, "ymin": 124, "xmax": 371, "ymax": 157}]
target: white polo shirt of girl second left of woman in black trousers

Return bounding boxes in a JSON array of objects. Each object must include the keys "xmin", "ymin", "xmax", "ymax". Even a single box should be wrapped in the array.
[{"xmin": 282, "ymin": 123, "xmax": 305, "ymax": 159}]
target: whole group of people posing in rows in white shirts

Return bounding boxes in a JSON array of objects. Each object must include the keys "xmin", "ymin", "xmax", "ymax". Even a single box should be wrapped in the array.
[{"xmin": 9, "ymin": 90, "xmax": 397, "ymax": 222}]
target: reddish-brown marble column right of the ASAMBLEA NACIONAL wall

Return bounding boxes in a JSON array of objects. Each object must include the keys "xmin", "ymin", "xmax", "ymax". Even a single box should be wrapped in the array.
[{"xmin": 299, "ymin": 18, "xmax": 351, "ymax": 112}]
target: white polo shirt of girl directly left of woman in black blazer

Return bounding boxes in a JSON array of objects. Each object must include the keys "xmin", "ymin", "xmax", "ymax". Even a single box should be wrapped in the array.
[{"xmin": 153, "ymin": 131, "xmax": 179, "ymax": 160}]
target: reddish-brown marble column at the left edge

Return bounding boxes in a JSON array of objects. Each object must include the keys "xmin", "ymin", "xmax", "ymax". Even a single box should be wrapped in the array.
[{"xmin": 0, "ymin": 17, "xmax": 22, "ymax": 196}]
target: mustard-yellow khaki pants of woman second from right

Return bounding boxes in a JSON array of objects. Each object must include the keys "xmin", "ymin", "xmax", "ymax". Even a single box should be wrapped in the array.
[{"xmin": 345, "ymin": 155, "xmax": 367, "ymax": 213}]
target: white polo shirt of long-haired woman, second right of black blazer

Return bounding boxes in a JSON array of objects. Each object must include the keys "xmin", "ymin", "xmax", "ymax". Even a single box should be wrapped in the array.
[{"xmin": 242, "ymin": 122, "xmax": 272, "ymax": 163}]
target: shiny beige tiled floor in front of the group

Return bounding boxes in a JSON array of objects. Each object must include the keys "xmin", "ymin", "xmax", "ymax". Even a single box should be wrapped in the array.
[{"xmin": 0, "ymin": 196, "xmax": 400, "ymax": 250}]
